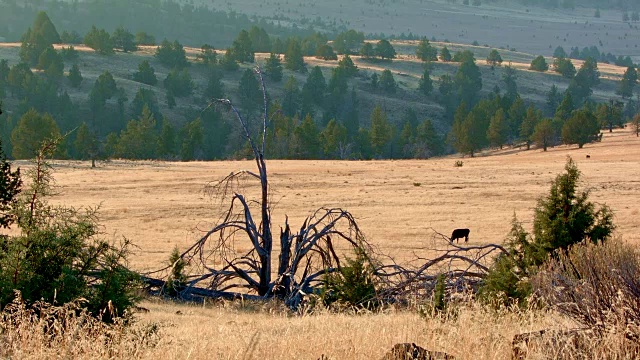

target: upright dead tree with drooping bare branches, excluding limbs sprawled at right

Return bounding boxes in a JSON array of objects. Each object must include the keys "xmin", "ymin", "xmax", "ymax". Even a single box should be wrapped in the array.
[{"xmin": 145, "ymin": 68, "xmax": 371, "ymax": 307}]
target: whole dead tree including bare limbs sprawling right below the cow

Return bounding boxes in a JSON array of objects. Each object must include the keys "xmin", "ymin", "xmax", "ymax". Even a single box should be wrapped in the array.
[{"xmin": 143, "ymin": 68, "xmax": 505, "ymax": 308}]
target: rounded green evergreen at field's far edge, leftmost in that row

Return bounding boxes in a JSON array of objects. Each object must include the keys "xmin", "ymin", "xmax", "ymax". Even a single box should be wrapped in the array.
[{"xmin": 11, "ymin": 109, "xmax": 60, "ymax": 159}]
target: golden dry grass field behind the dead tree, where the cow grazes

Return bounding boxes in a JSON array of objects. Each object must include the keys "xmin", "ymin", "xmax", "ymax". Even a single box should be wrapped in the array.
[{"xmin": 26, "ymin": 126, "xmax": 640, "ymax": 269}]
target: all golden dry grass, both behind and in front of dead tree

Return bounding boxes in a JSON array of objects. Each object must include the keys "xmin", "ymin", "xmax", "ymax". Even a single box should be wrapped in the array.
[{"xmin": 0, "ymin": 129, "xmax": 640, "ymax": 359}]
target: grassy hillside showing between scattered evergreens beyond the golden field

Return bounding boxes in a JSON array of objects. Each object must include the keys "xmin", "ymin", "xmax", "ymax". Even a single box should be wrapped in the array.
[{"xmin": 0, "ymin": 41, "xmax": 624, "ymax": 132}]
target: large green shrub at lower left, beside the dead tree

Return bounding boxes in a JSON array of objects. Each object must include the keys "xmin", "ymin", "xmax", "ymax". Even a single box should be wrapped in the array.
[{"xmin": 0, "ymin": 142, "xmax": 137, "ymax": 322}]
